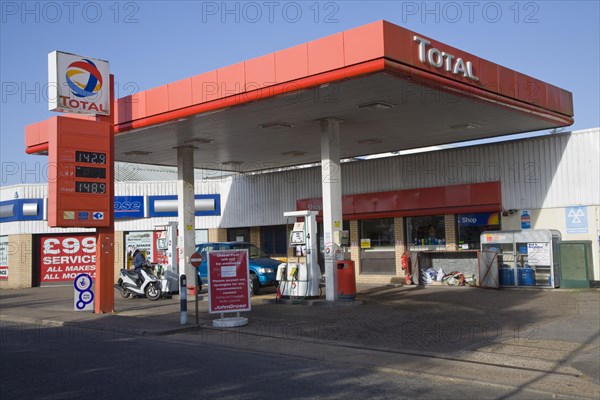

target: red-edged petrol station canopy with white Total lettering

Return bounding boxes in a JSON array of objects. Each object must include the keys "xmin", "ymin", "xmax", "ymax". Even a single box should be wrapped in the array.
[{"xmin": 26, "ymin": 21, "xmax": 573, "ymax": 172}]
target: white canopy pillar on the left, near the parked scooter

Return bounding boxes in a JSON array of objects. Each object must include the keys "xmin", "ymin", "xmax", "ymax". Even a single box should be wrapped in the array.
[{"xmin": 177, "ymin": 146, "xmax": 196, "ymax": 295}]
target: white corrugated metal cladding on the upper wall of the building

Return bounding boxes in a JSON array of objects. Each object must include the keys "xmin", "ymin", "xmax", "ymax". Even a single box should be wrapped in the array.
[{"xmin": 0, "ymin": 128, "xmax": 600, "ymax": 234}]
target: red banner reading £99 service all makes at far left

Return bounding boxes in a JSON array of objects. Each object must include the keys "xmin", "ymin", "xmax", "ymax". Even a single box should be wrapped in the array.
[{"xmin": 38, "ymin": 235, "xmax": 96, "ymax": 284}]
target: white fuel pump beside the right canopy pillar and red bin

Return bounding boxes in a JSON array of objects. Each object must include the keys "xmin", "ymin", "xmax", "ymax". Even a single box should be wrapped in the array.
[{"xmin": 276, "ymin": 210, "xmax": 321, "ymax": 301}]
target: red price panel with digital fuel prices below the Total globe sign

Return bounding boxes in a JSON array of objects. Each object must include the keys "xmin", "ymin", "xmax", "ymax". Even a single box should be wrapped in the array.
[{"xmin": 48, "ymin": 116, "xmax": 114, "ymax": 227}]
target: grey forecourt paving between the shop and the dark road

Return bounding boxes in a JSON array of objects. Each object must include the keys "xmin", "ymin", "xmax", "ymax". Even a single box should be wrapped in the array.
[{"xmin": 0, "ymin": 285, "xmax": 600, "ymax": 398}]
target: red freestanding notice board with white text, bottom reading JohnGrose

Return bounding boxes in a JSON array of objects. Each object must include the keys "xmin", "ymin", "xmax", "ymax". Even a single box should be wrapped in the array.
[{"xmin": 208, "ymin": 250, "xmax": 250, "ymax": 314}]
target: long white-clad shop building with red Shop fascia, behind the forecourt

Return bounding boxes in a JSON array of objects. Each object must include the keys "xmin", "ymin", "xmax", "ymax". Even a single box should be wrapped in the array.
[{"xmin": 0, "ymin": 128, "xmax": 600, "ymax": 288}]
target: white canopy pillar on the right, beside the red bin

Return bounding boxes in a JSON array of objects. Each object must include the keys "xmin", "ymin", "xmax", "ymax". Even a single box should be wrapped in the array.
[{"xmin": 321, "ymin": 118, "xmax": 342, "ymax": 301}]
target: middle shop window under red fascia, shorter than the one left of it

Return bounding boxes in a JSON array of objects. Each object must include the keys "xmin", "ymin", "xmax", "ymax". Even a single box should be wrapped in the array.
[{"xmin": 406, "ymin": 215, "xmax": 446, "ymax": 251}]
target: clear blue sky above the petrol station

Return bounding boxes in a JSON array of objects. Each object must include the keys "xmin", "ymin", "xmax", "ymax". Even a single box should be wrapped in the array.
[{"xmin": 0, "ymin": 0, "xmax": 600, "ymax": 186}]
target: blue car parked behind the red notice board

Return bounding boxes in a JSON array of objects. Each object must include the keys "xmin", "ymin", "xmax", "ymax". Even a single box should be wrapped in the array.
[{"xmin": 196, "ymin": 242, "xmax": 281, "ymax": 294}]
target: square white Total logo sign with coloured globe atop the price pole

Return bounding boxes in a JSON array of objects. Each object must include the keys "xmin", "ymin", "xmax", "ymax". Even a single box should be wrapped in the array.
[{"xmin": 48, "ymin": 51, "xmax": 110, "ymax": 115}]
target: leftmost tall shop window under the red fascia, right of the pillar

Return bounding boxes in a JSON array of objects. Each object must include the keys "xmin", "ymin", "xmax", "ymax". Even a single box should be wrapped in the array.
[{"xmin": 360, "ymin": 218, "xmax": 396, "ymax": 275}]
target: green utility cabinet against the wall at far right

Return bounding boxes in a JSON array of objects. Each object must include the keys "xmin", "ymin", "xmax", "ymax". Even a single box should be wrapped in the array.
[{"xmin": 558, "ymin": 240, "xmax": 594, "ymax": 288}]
